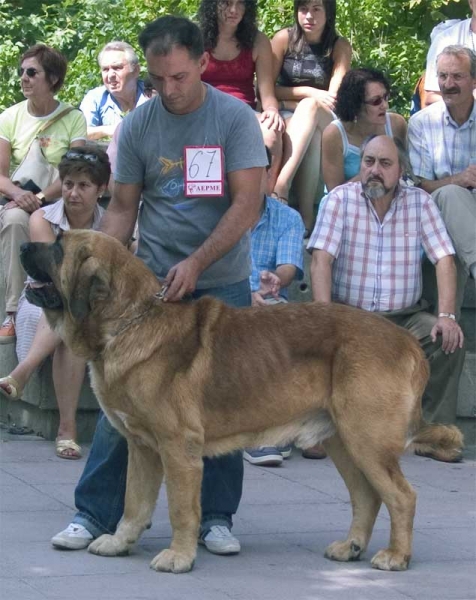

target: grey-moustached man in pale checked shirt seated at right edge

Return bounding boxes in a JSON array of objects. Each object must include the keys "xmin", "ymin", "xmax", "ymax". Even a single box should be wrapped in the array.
[{"xmin": 408, "ymin": 45, "xmax": 476, "ymax": 313}]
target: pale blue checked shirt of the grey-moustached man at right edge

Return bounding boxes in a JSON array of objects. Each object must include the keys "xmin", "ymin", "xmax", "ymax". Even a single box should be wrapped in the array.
[{"xmin": 408, "ymin": 102, "xmax": 476, "ymax": 180}]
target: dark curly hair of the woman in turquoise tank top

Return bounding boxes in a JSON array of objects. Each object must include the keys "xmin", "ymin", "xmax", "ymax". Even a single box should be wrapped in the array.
[{"xmin": 334, "ymin": 69, "xmax": 390, "ymax": 121}]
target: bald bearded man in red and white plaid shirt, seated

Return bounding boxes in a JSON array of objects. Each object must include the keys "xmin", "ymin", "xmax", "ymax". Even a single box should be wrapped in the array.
[{"xmin": 308, "ymin": 136, "xmax": 464, "ymax": 462}]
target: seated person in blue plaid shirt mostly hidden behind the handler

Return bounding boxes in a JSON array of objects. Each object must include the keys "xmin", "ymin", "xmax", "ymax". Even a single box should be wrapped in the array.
[{"xmin": 244, "ymin": 148, "xmax": 304, "ymax": 466}]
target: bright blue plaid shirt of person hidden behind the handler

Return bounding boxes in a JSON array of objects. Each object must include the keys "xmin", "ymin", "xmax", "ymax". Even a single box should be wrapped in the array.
[{"xmin": 250, "ymin": 197, "xmax": 304, "ymax": 298}]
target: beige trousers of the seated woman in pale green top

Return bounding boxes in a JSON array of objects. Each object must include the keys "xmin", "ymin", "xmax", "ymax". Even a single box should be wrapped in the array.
[{"xmin": 0, "ymin": 208, "xmax": 30, "ymax": 312}]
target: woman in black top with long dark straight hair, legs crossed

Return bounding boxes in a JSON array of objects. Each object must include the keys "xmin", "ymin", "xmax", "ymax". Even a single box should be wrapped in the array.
[{"xmin": 271, "ymin": 0, "xmax": 352, "ymax": 230}]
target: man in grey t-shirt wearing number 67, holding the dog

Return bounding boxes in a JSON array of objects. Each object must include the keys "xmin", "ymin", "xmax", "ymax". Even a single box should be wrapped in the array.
[{"xmin": 52, "ymin": 16, "xmax": 268, "ymax": 568}]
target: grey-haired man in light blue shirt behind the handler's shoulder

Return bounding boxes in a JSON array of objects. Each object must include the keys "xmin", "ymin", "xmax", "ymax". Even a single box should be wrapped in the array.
[{"xmin": 79, "ymin": 42, "xmax": 148, "ymax": 140}]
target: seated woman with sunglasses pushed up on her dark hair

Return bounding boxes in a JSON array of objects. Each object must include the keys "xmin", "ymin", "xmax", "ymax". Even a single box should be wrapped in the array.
[{"xmin": 0, "ymin": 145, "xmax": 111, "ymax": 459}]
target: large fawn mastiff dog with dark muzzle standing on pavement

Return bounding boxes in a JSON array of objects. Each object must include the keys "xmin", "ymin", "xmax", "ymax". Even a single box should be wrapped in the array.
[{"xmin": 22, "ymin": 231, "xmax": 461, "ymax": 573}]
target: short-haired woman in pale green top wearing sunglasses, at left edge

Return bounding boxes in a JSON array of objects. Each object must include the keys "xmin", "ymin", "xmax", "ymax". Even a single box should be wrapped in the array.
[{"xmin": 0, "ymin": 44, "xmax": 86, "ymax": 343}]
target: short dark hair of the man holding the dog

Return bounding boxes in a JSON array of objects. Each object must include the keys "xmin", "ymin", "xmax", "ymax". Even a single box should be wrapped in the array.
[{"xmin": 139, "ymin": 15, "xmax": 205, "ymax": 59}]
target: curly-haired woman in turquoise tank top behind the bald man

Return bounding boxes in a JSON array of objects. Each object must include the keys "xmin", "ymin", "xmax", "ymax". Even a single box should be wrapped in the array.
[{"xmin": 322, "ymin": 69, "xmax": 407, "ymax": 191}]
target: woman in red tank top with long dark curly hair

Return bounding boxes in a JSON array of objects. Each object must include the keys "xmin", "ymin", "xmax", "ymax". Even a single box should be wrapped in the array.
[{"xmin": 198, "ymin": 0, "xmax": 284, "ymax": 191}]
